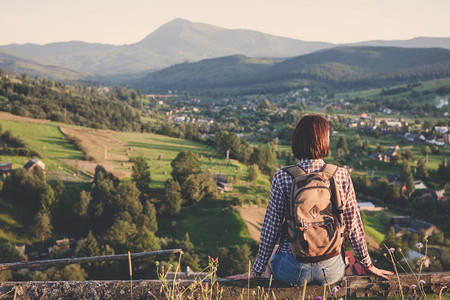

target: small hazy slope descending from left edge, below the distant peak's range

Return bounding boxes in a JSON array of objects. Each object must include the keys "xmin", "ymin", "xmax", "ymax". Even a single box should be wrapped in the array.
[{"xmin": 0, "ymin": 49, "xmax": 88, "ymax": 80}]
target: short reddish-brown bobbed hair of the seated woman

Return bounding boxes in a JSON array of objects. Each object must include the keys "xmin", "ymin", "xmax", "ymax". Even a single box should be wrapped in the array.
[{"xmin": 292, "ymin": 114, "xmax": 330, "ymax": 159}]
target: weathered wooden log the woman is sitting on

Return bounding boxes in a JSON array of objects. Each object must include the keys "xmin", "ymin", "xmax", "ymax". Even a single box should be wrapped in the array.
[{"xmin": 0, "ymin": 272, "xmax": 450, "ymax": 300}]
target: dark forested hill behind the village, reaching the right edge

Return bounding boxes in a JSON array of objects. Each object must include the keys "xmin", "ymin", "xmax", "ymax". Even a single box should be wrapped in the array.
[{"xmin": 130, "ymin": 47, "xmax": 450, "ymax": 92}]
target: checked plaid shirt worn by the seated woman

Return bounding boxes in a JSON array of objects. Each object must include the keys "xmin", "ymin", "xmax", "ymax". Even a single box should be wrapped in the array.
[{"xmin": 253, "ymin": 159, "xmax": 371, "ymax": 273}]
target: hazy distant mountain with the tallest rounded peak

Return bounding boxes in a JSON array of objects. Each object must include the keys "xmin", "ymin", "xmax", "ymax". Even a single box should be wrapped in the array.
[{"xmin": 1, "ymin": 19, "xmax": 335, "ymax": 75}]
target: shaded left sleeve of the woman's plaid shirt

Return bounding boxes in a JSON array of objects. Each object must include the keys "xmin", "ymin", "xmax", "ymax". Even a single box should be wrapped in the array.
[{"xmin": 253, "ymin": 171, "xmax": 289, "ymax": 273}]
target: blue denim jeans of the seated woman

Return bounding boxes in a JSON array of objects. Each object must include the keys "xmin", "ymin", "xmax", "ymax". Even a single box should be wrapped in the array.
[{"xmin": 271, "ymin": 252, "xmax": 345, "ymax": 285}]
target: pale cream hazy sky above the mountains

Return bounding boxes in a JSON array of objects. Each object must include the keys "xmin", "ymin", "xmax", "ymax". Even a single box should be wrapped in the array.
[{"xmin": 0, "ymin": 0, "xmax": 450, "ymax": 45}]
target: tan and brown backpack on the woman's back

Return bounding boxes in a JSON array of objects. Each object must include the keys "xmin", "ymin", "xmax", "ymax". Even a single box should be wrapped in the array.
[{"xmin": 284, "ymin": 164, "xmax": 344, "ymax": 263}]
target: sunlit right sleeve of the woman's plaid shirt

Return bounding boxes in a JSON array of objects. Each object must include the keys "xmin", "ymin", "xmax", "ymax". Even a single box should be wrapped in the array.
[{"xmin": 342, "ymin": 172, "xmax": 372, "ymax": 268}]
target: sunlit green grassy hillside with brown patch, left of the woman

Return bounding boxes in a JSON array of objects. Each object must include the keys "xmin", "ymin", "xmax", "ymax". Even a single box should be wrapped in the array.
[{"xmin": 0, "ymin": 113, "xmax": 270, "ymax": 268}]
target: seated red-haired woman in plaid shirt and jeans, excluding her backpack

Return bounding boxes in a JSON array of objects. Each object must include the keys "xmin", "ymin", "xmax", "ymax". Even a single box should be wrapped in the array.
[{"xmin": 227, "ymin": 115, "xmax": 393, "ymax": 285}]
